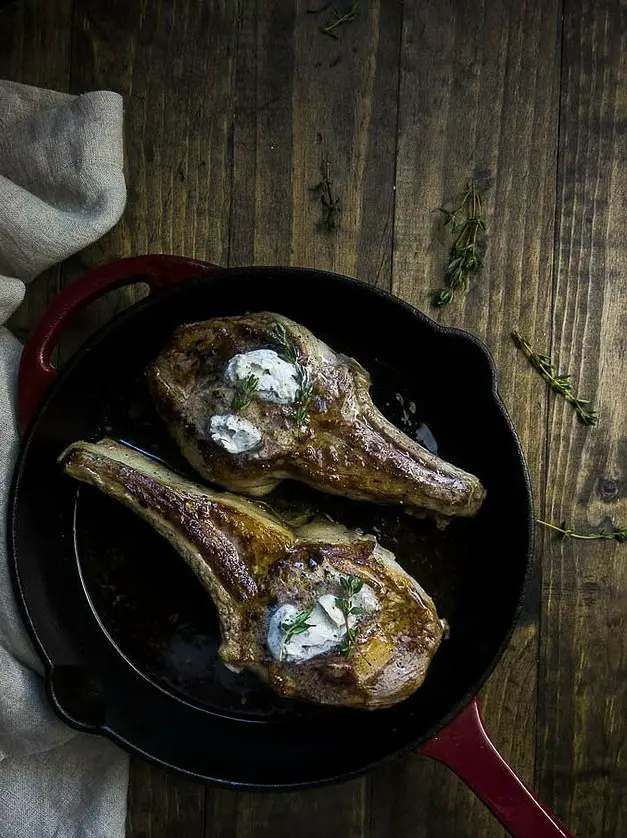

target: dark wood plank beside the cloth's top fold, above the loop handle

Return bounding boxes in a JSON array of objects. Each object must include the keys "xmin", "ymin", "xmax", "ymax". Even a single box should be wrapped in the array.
[{"xmin": 57, "ymin": 0, "xmax": 238, "ymax": 355}]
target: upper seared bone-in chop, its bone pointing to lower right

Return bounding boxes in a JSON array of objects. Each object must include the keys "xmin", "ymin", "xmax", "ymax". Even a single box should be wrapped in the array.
[{"xmin": 148, "ymin": 313, "xmax": 485, "ymax": 517}]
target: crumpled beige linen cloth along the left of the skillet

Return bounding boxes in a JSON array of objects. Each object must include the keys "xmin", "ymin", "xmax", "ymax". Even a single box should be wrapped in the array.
[{"xmin": 0, "ymin": 80, "xmax": 128, "ymax": 838}]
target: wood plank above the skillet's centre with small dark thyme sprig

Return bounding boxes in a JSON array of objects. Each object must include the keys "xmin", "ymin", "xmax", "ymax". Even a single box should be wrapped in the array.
[{"xmin": 213, "ymin": 0, "xmax": 400, "ymax": 838}]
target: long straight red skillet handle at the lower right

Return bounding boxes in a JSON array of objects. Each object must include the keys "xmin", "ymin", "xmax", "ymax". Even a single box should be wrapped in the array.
[{"xmin": 419, "ymin": 699, "xmax": 572, "ymax": 838}]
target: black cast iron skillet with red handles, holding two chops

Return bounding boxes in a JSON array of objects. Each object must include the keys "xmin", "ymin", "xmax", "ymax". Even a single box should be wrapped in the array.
[{"xmin": 10, "ymin": 256, "xmax": 567, "ymax": 838}]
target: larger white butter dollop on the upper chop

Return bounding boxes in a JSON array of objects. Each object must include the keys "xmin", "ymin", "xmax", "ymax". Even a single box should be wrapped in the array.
[{"xmin": 226, "ymin": 349, "xmax": 299, "ymax": 404}]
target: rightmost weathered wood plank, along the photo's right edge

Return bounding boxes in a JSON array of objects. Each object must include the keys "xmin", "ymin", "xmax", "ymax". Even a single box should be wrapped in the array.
[{"xmin": 538, "ymin": 0, "xmax": 627, "ymax": 838}]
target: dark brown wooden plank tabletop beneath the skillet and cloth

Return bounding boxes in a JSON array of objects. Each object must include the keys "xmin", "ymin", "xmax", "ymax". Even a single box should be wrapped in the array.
[{"xmin": 0, "ymin": 0, "xmax": 627, "ymax": 838}]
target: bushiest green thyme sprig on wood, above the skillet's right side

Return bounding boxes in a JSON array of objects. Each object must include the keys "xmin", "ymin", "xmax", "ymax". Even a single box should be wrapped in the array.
[{"xmin": 433, "ymin": 180, "xmax": 486, "ymax": 307}]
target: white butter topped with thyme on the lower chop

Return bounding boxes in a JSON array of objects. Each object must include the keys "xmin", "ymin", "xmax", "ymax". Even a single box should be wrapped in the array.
[{"xmin": 267, "ymin": 585, "xmax": 379, "ymax": 663}]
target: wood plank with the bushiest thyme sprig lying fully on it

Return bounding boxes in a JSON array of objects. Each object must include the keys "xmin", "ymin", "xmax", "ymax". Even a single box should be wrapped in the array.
[{"xmin": 388, "ymin": 0, "xmax": 561, "ymax": 838}]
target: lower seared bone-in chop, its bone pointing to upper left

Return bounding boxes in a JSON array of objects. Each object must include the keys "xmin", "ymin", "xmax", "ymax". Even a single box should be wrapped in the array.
[{"xmin": 60, "ymin": 439, "xmax": 444, "ymax": 709}]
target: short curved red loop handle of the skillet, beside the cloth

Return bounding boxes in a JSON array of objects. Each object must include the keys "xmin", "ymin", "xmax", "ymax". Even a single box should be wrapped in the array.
[{"xmin": 17, "ymin": 254, "xmax": 218, "ymax": 429}]
